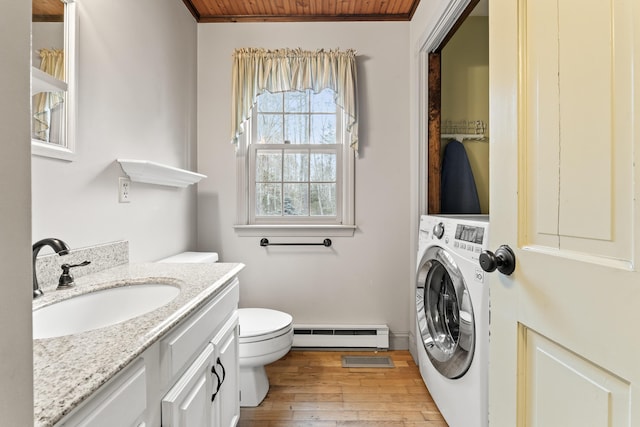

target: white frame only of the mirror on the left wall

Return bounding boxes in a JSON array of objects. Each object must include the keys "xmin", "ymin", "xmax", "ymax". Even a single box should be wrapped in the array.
[{"xmin": 31, "ymin": 0, "xmax": 78, "ymax": 161}]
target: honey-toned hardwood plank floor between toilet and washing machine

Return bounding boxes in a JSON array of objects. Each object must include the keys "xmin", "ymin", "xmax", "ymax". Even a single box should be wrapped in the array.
[{"xmin": 238, "ymin": 350, "xmax": 447, "ymax": 427}]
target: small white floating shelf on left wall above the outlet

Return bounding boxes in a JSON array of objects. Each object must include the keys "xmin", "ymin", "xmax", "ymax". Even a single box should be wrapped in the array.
[{"xmin": 117, "ymin": 159, "xmax": 207, "ymax": 187}]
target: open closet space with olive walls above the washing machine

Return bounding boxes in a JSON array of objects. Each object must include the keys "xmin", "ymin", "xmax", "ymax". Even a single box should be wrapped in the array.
[{"xmin": 423, "ymin": 0, "xmax": 489, "ymax": 214}]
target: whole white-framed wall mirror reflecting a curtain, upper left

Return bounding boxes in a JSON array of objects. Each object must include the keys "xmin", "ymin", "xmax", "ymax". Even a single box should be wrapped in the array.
[{"xmin": 31, "ymin": 0, "xmax": 78, "ymax": 161}]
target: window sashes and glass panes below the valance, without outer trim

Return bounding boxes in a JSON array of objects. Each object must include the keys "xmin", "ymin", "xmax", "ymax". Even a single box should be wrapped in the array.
[{"xmin": 249, "ymin": 89, "xmax": 342, "ymax": 224}]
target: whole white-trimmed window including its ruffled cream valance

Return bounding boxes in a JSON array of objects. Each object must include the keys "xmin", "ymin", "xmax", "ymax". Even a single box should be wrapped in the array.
[{"xmin": 232, "ymin": 49, "xmax": 357, "ymax": 237}]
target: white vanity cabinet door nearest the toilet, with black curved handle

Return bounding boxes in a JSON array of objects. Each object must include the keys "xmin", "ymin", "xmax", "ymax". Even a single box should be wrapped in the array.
[{"xmin": 212, "ymin": 312, "xmax": 240, "ymax": 427}]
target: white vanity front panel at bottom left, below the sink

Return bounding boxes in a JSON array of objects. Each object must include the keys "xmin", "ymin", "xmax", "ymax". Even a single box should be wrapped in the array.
[{"xmin": 61, "ymin": 359, "xmax": 147, "ymax": 427}]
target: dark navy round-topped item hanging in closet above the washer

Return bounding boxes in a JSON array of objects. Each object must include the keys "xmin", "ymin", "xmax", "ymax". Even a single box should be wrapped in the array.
[{"xmin": 440, "ymin": 139, "xmax": 480, "ymax": 214}]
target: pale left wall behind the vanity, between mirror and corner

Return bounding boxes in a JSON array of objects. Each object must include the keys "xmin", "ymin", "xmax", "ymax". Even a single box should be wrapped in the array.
[{"xmin": 32, "ymin": 0, "xmax": 197, "ymax": 261}]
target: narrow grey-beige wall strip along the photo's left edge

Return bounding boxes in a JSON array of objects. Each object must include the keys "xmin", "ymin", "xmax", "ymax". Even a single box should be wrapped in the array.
[{"xmin": 0, "ymin": 2, "xmax": 33, "ymax": 426}]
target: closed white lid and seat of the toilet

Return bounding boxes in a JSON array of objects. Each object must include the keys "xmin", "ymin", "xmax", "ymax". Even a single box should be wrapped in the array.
[{"xmin": 238, "ymin": 308, "xmax": 293, "ymax": 342}]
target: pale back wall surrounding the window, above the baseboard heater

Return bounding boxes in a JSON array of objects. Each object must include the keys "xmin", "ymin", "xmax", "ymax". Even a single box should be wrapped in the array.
[{"xmin": 198, "ymin": 22, "xmax": 414, "ymax": 348}]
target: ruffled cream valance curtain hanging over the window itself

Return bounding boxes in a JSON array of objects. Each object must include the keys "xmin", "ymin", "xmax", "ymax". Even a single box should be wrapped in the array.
[{"xmin": 231, "ymin": 48, "xmax": 358, "ymax": 150}]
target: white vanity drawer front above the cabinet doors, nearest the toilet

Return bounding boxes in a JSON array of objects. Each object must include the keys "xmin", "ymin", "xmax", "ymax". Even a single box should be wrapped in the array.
[{"xmin": 160, "ymin": 278, "xmax": 240, "ymax": 385}]
